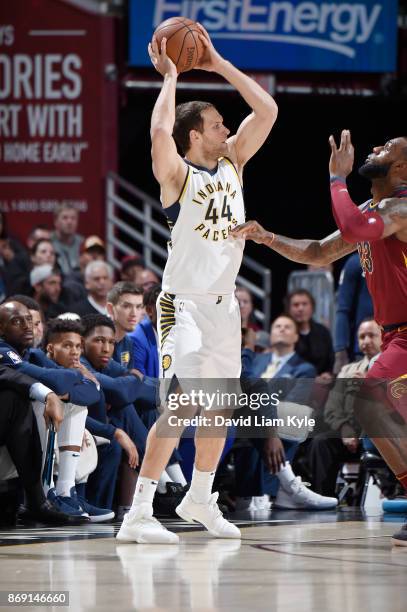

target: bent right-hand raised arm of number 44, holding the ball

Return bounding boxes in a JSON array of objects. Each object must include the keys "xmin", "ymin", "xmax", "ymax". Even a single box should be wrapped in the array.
[{"xmin": 196, "ymin": 24, "xmax": 278, "ymax": 170}]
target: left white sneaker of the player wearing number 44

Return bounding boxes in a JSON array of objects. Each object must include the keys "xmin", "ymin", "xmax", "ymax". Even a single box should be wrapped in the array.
[{"xmin": 116, "ymin": 503, "xmax": 179, "ymax": 544}]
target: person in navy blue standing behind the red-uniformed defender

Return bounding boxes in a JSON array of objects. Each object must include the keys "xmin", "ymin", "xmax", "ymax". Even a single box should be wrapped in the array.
[{"xmin": 334, "ymin": 253, "xmax": 373, "ymax": 374}]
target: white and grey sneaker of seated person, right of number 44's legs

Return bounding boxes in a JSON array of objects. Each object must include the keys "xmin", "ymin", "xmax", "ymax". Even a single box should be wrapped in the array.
[{"xmin": 273, "ymin": 476, "xmax": 338, "ymax": 510}]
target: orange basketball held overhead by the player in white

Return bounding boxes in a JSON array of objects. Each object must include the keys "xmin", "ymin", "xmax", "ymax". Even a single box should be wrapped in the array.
[{"xmin": 154, "ymin": 17, "xmax": 204, "ymax": 73}]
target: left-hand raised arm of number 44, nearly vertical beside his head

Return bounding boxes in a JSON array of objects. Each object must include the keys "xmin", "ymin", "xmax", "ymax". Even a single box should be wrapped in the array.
[{"xmin": 148, "ymin": 37, "xmax": 185, "ymax": 189}]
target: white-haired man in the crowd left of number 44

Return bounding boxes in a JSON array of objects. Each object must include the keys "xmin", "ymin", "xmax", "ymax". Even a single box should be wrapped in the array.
[{"xmin": 71, "ymin": 261, "xmax": 113, "ymax": 317}]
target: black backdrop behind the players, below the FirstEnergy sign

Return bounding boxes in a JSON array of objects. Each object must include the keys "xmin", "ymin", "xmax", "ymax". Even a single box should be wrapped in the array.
[{"xmin": 120, "ymin": 90, "xmax": 407, "ymax": 316}]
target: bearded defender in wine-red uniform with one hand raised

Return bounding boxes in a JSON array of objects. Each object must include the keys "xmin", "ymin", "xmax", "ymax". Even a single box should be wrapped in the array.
[{"xmin": 232, "ymin": 130, "xmax": 407, "ymax": 546}]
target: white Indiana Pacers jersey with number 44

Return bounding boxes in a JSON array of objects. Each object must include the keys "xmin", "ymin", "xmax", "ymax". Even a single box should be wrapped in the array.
[{"xmin": 162, "ymin": 157, "xmax": 245, "ymax": 295}]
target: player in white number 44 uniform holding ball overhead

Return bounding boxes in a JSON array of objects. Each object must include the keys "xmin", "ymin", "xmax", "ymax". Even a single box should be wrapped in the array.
[{"xmin": 117, "ymin": 26, "xmax": 277, "ymax": 544}]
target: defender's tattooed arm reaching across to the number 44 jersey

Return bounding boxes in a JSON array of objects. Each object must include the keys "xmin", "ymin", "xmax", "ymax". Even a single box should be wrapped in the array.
[{"xmin": 230, "ymin": 221, "xmax": 356, "ymax": 265}]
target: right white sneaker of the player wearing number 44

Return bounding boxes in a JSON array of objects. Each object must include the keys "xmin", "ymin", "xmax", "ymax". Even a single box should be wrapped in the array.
[{"xmin": 175, "ymin": 491, "xmax": 241, "ymax": 538}]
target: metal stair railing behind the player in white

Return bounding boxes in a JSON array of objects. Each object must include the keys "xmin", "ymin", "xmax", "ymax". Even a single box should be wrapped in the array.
[{"xmin": 106, "ymin": 172, "xmax": 271, "ymax": 330}]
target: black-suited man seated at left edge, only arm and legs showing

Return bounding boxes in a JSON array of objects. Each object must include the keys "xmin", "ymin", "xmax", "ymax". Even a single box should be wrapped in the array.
[{"xmin": 0, "ymin": 365, "xmax": 84, "ymax": 525}]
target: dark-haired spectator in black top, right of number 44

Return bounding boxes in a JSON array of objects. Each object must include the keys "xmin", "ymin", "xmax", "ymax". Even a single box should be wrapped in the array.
[{"xmin": 285, "ymin": 289, "xmax": 335, "ymax": 382}]
